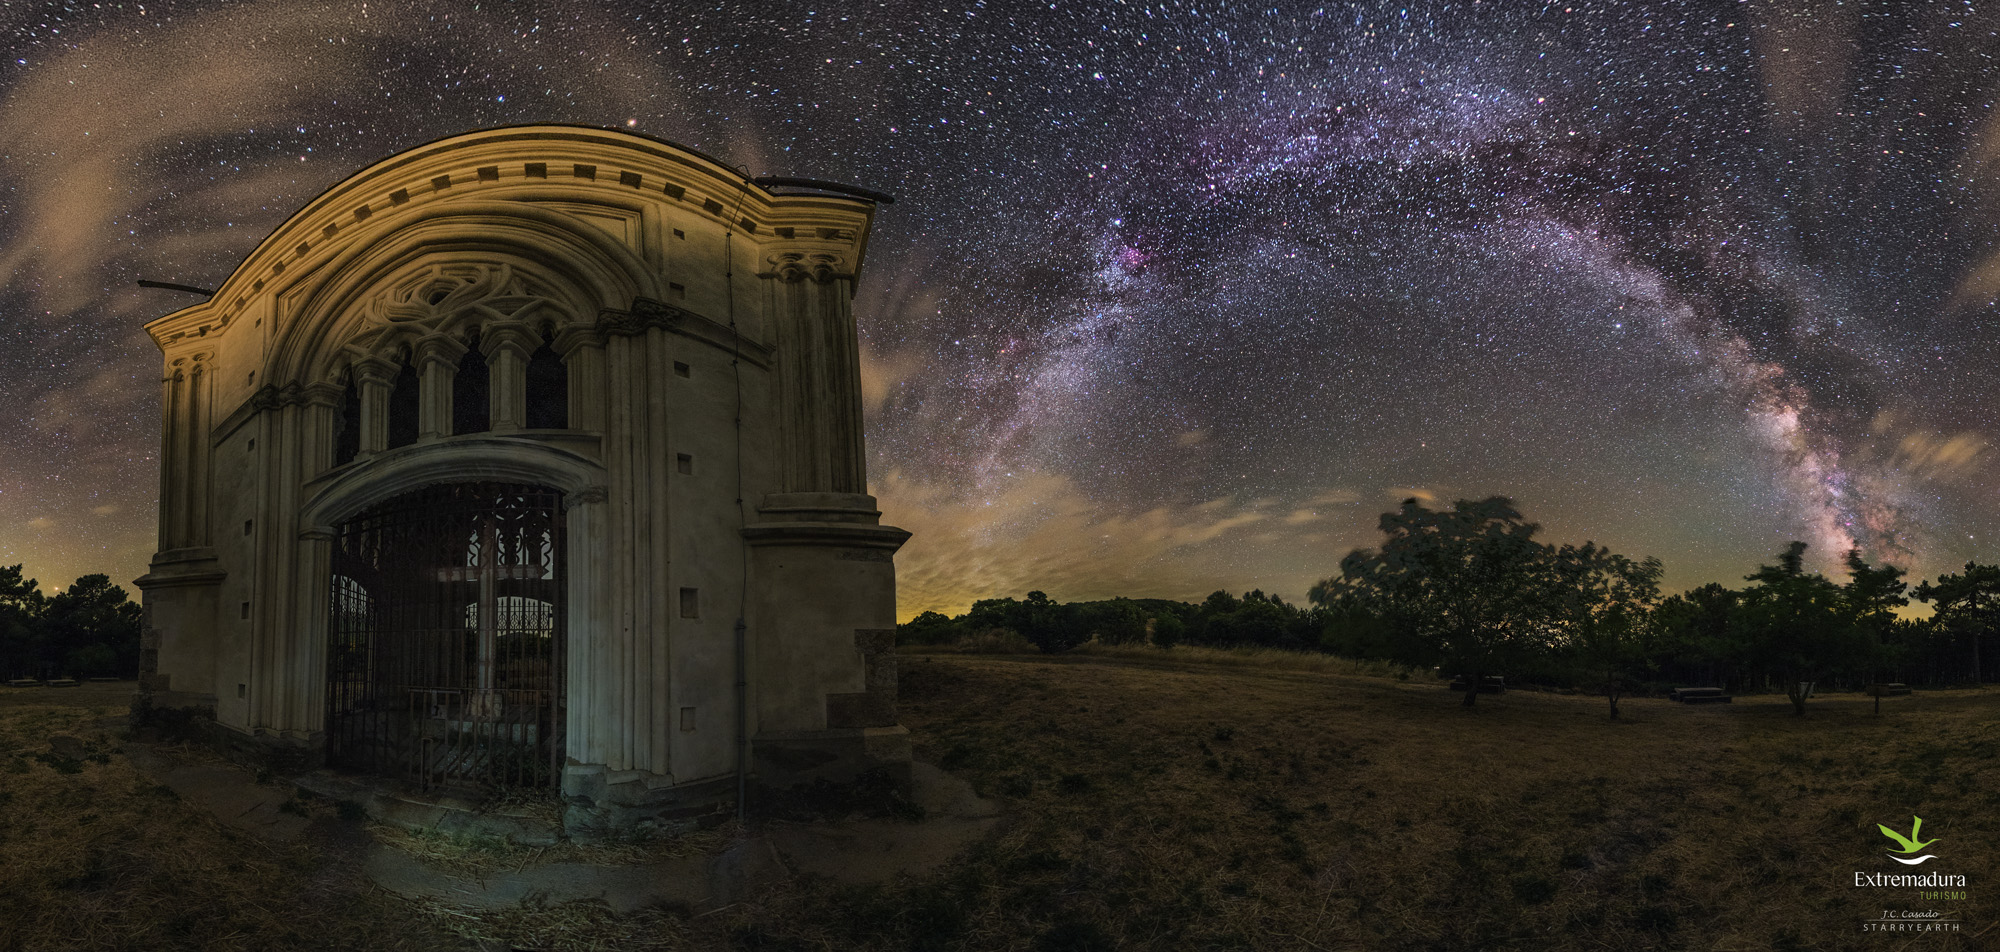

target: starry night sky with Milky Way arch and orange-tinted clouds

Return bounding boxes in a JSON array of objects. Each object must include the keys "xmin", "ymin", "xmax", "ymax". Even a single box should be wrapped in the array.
[{"xmin": 0, "ymin": 2, "xmax": 2000, "ymax": 616}]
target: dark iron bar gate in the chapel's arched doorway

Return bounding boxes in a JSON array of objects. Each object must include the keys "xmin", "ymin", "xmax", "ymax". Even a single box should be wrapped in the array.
[{"xmin": 326, "ymin": 482, "xmax": 564, "ymax": 790}]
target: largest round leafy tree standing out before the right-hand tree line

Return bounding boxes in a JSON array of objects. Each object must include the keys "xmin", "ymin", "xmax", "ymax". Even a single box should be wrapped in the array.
[{"xmin": 1310, "ymin": 496, "xmax": 1564, "ymax": 706}]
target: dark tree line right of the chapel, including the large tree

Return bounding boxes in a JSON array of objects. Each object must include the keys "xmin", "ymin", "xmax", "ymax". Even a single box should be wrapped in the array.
[{"xmin": 898, "ymin": 496, "xmax": 2000, "ymax": 718}]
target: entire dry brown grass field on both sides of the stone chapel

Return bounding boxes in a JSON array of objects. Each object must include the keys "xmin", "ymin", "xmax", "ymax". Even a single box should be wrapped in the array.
[{"xmin": 0, "ymin": 650, "xmax": 2000, "ymax": 952}]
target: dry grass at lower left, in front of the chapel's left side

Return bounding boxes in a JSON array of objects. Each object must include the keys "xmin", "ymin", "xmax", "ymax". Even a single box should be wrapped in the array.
[{"xmin": 0, "ymin": 682, "xmax": 694, "ymax": 952}]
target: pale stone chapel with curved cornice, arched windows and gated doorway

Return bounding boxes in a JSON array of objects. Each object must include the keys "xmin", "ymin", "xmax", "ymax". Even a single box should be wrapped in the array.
[{"xmin": 136, "ymin": 126, "xmax": 910, "ymax": 828}]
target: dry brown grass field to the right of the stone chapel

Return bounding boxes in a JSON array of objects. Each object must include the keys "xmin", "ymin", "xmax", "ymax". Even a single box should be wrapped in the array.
[{"xmin": 740, "ymin": 650, "xmax": 2000, "ymax": 950}]
